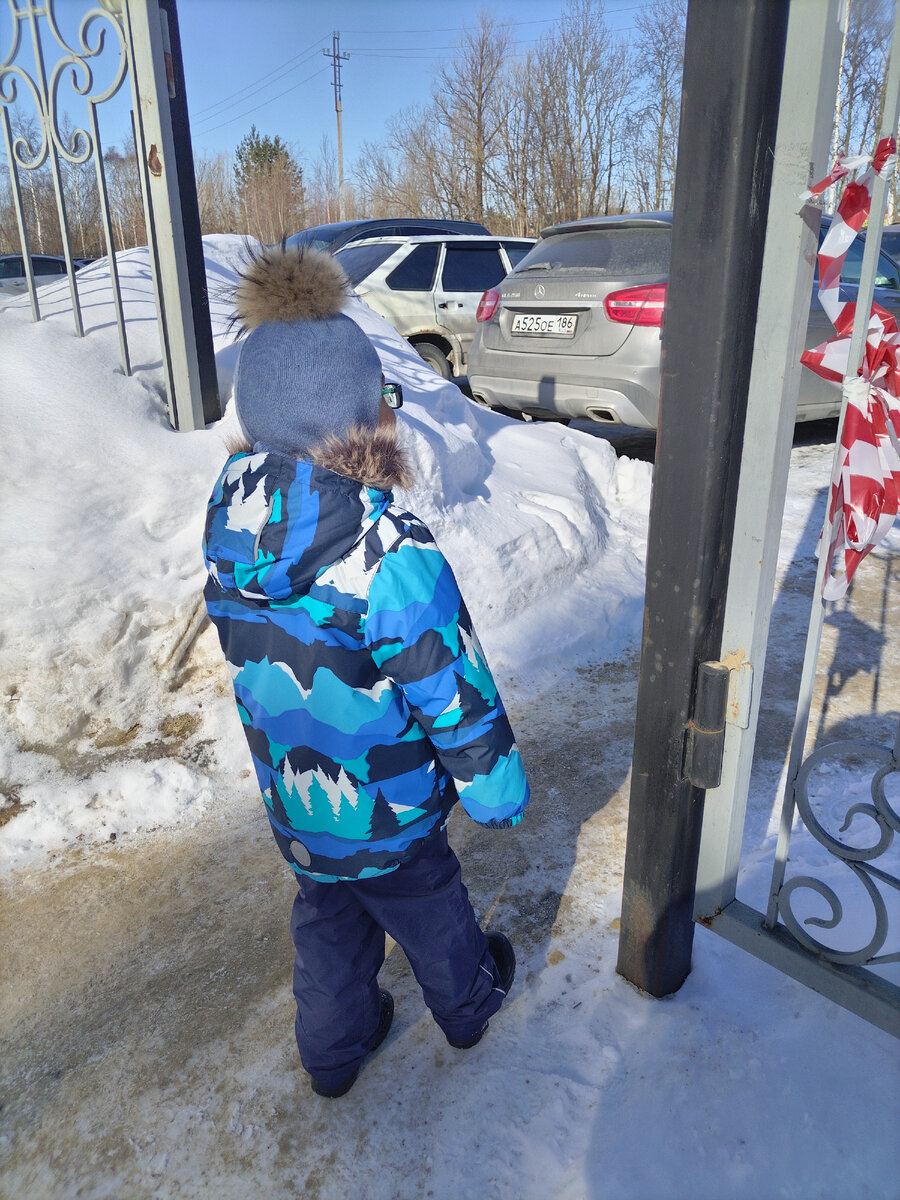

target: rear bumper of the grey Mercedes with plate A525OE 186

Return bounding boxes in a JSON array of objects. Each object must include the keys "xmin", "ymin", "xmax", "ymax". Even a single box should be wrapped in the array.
[{"xmin": 468, "ymin": 370, "xmax": 659, "ymax": 430}]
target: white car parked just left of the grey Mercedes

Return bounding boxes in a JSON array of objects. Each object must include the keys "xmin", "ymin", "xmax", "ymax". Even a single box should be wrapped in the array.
[{"xmin": 335, "ymin": 235, "xmax": 534, "ymax": 379}]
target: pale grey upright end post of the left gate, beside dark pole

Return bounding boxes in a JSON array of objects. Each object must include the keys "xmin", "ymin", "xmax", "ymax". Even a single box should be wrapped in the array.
[{"xmin": 125, "ymin": 0, "xmax": 205, "ymax": 430}]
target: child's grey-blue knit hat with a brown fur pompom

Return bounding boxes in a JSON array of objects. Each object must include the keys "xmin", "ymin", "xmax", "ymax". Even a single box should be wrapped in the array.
[{"xmin": 234, "ymin": 246, "xmax": 382, "ymax": 455}]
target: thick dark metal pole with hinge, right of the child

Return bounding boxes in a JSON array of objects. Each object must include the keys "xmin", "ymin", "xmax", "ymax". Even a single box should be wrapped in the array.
[{"xmin": 617, "ymin": 0, "xmax": 788, "ymax": 996}]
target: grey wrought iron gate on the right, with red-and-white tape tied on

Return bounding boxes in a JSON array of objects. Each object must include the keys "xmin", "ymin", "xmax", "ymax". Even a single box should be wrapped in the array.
[{"xmin": 695, "ymin": 2, "xmax": 900, "ymax": 1036}]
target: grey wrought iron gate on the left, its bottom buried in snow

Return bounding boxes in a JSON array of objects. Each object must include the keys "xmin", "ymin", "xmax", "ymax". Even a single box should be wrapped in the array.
[{"xmin": 0, "ymin": 0, "xmax": 217, "ymax": 430}]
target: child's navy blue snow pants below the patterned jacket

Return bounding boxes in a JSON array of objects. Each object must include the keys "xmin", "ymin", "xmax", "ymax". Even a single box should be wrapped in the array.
[{"xmin": 290, "ymin": 830, "xmax": 504, "ymax": 1085}]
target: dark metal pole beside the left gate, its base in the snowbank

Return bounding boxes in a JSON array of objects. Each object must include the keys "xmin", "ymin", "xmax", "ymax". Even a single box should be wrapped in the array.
[{"xmin": 160, "ymin": 0, "xmax": 222, "ymax": 425}]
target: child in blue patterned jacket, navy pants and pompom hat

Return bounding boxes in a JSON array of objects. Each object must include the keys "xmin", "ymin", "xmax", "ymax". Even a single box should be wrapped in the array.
[{"xmin": 204, "ymin": 248, "xmax": 528, "ymax": 1097}]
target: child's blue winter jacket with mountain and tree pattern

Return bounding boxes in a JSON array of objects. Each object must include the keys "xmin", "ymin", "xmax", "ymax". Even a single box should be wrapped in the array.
[{"xmin": 204, "ymin": 439, "xmax": 528, "ymax": 881}]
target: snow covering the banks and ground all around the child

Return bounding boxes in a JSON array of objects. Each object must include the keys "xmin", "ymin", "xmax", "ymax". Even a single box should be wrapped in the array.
[{"xmin": 0, "ymin": 236, "xmax": 900, "ymax": 1200}]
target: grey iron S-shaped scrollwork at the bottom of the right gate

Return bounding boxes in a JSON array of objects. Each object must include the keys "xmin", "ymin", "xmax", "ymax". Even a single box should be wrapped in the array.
[{"xmin": 767, "ymin": 726, "xmax": 900, "ymax": 966}]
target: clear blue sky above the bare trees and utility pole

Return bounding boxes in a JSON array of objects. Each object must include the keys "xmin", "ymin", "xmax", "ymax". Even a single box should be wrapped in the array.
[{"xmin": 7, "ymin": 0, "xmax": 647, "ymax": 170}]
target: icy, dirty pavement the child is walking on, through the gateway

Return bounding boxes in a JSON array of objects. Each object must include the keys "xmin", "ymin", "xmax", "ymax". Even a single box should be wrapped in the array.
[{"xmin": 0, "ymin": 448, "xmax": 900, "ymax": 1200}]
